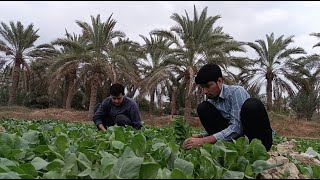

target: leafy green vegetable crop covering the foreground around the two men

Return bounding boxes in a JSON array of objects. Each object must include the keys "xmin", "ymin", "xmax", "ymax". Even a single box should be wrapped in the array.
[{"xmin": 0, "ymin": 118, "xmax": 320, "ymax": 179}]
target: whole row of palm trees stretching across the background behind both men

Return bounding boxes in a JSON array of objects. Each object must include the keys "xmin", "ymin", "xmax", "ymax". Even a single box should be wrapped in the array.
[{"xmin": 0, "ymin": 7, "xmax": 320, "ymax": 120}]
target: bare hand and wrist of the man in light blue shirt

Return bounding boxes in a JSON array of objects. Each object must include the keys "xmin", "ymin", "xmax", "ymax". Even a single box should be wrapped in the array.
[{"xmin": 183, "ymin": 134, "xmax": 217, "ymax": 149}]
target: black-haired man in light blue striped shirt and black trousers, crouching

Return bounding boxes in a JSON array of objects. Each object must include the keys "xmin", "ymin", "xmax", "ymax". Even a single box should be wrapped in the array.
[{"xmin": 184, "ymin": 64, "xmax": 272, "ymax": 151}]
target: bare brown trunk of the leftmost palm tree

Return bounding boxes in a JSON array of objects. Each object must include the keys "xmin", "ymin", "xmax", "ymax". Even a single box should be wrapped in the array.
[{"xmin": 8, "ymin": 63, "xmax": 20, "ymax": 106}]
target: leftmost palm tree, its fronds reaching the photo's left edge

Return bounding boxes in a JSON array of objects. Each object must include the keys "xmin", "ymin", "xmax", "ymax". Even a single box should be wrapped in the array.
[{"xmin": 0, "ymin": 21, "xmax": 39, "ymax": 105}]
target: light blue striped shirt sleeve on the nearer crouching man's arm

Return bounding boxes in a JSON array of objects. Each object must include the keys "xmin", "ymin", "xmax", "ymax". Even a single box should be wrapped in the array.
[{"xmin": 213, "ymin": 87, "xmax": 250, "ymax": 141}]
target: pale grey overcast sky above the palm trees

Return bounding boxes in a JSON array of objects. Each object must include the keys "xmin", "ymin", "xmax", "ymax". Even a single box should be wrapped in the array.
[{"xmin": 0, "ymin": 1, "xmax": 320, "ymax": 54}]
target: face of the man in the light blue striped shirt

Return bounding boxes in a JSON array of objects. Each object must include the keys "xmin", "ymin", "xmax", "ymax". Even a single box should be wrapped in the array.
[{"xmin": 200, "ymin": 78, "xmax": 222, "ymax": 99}]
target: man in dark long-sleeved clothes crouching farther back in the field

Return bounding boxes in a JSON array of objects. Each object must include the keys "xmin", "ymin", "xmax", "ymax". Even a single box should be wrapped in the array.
[{"xmin": 93, "ymin": 83, "xmax": 142, "ymax": 131}]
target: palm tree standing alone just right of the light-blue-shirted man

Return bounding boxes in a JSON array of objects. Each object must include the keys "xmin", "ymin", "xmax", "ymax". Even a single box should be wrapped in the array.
[{"xmin": 246, "ymin": 33, "xmax": 305, "ymax": 110}]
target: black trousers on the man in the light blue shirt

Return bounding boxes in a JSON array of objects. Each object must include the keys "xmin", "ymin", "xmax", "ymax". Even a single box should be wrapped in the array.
[{"xmin": 197, "ymin": 98, "xmax": 272, "ymax": 151}]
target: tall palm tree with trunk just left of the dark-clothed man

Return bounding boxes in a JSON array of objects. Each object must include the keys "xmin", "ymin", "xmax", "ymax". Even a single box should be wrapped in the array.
[{"xmin": 76, "ymin": 14, "xmax": 125, "ymax": 120}]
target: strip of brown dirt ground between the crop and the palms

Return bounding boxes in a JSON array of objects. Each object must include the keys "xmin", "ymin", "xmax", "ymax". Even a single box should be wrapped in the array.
[{"xmin": 0, "ymin": 106, "xmax": 320, "ymax": 139}]
